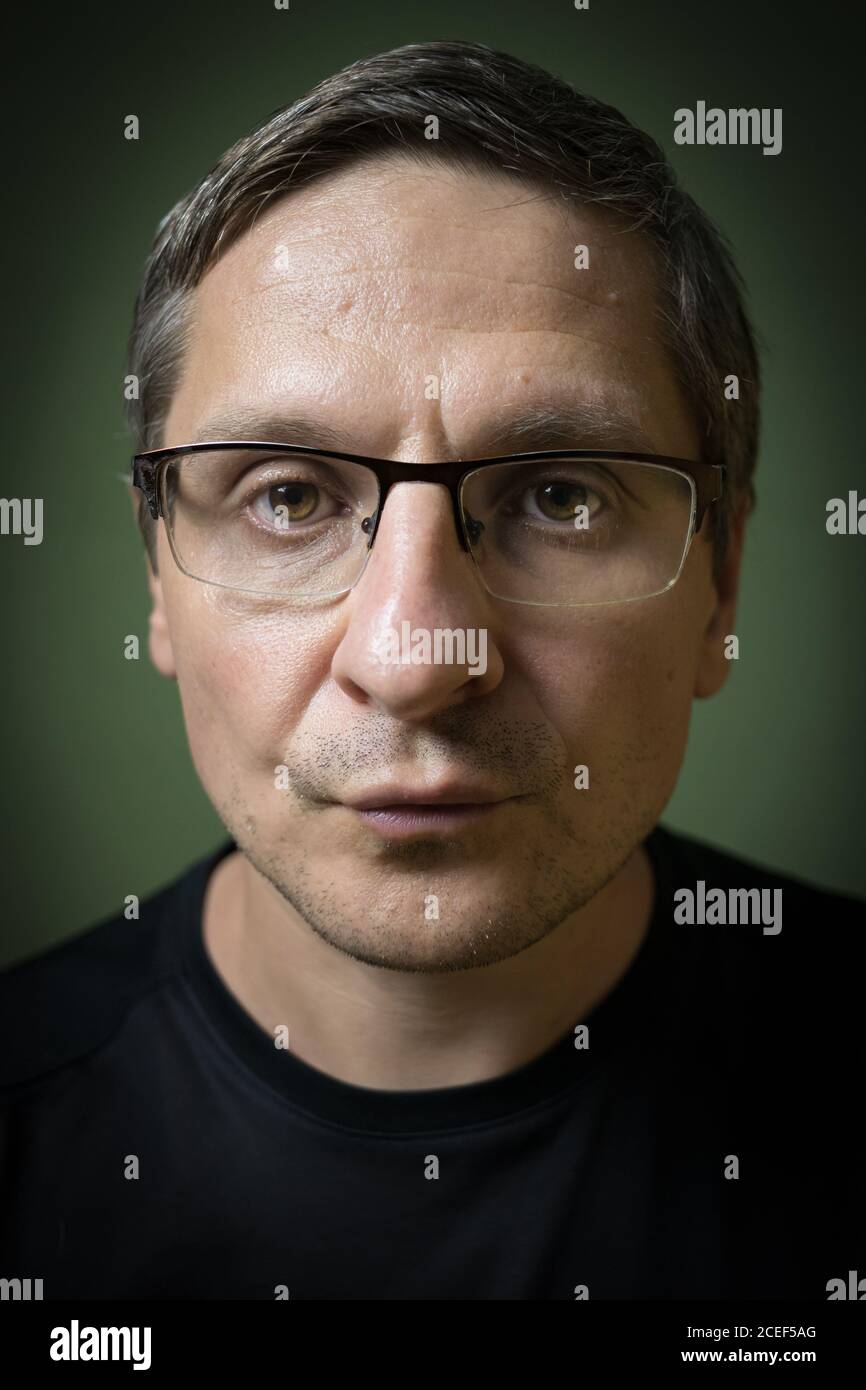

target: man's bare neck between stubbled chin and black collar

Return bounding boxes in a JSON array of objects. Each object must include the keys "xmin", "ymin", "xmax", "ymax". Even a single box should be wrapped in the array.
[{"xmin": 203, "ymin": 847, "xmax": 653, "ymax": 1090}]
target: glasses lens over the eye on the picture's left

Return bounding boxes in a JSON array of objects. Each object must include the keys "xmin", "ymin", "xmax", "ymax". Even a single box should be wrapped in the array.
[{"xmin": 163, "ymin": 449, "xmax": 378, "ymax": 598}]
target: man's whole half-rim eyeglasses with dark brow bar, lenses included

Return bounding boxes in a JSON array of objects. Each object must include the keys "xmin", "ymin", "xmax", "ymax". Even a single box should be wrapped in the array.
[{"xmin": 132, "ymin": 441, "xmax": 726, "ymax": 607}]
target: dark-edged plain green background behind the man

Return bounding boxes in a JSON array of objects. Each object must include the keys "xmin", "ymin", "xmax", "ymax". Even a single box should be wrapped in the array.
[{"xmin": 0, "ymin": 0, "xmax": 866, "ymax": 960}]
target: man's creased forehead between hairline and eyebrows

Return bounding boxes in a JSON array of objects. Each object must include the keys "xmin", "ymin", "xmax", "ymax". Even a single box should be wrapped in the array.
[{"xmin": 167, "ymin": 157, "xmax": 697, "ymax": 453}]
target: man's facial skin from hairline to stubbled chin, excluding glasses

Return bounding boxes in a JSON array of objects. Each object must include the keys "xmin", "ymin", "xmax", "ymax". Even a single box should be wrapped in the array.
[{"xmin": 150, "ymin": 160, "xmax": 733, "ymax": 970}]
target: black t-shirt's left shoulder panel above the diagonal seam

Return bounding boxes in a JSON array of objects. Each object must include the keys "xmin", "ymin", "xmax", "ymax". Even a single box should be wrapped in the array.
[{"xmin": 0, "ymin": 855, "xmax": 226, "ymax": 1097}]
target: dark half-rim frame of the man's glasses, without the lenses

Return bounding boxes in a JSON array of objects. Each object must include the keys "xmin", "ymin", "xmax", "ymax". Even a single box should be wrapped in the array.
[{"xmin": 132, "ymin": 439, "xmax": 727, "ymax": 607}]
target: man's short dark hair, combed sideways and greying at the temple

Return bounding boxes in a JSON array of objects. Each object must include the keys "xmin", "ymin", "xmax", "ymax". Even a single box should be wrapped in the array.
[{"xmin": 126, "ymin": 40, "xmax": 760, "ymax": 569}]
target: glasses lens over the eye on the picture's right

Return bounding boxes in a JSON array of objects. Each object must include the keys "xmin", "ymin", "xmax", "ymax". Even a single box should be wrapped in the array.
[{"xmin": 461, "ymin": 459, "xmax": 694, "ymax": 606}]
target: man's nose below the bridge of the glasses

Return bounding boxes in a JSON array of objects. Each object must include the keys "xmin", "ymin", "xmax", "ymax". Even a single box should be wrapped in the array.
[{"xmin": 331, "ymin": 482, "xmax": 503, "ymax": 723}]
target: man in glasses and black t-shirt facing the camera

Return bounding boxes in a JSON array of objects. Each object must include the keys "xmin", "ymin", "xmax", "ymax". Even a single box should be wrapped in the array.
[{"xmin": 1, "ymin": 43, "xmax": 866, "ymax": 1300}]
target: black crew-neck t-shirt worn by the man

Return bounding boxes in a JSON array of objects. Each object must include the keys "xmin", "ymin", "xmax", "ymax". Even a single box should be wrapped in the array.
[{"xmin": 0, "ymin": 828, "xmax": 866, "ymax": 1300}]
